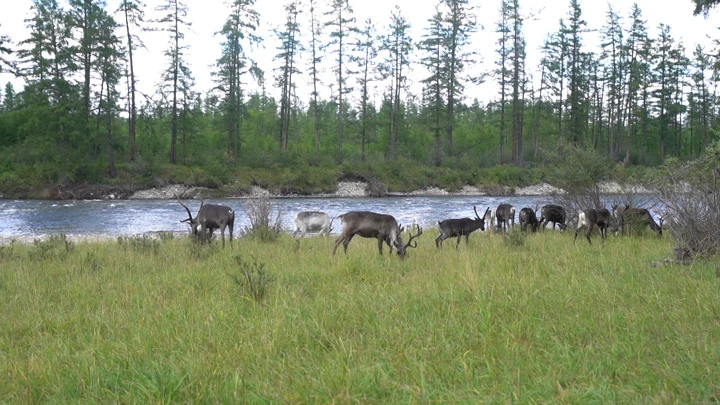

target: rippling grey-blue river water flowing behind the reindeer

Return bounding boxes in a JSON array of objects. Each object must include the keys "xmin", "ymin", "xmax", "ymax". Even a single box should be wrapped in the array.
[{"xmin": 0, "ymin": 196, "xmax": 552, "ymax": 240}]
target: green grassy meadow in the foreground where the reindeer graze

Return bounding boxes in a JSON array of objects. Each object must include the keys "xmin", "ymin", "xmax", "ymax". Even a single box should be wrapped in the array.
[{"xmin": 0, "ymin": 230, "xmax": 720, "ymax": 403}]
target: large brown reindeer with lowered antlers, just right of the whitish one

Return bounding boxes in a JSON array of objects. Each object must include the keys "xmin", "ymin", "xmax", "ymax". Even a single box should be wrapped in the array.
[{"xmin": 333, "ymin": 211, "xmax": 422, "ymax": 257}]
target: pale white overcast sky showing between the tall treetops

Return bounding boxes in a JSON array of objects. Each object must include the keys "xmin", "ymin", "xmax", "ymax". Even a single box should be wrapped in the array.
[{"xmin": 0, "ymin": 0, "xmax": 720, "ymax": 102}]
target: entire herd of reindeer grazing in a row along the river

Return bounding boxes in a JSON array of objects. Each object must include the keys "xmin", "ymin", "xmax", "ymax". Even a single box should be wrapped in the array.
[{"xmin": 177, "ymin": 198, "xmax": 663, "ymax": 257}]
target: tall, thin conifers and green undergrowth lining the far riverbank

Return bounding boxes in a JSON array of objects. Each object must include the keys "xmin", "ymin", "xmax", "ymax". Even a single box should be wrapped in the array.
[{"xmin": 0, "ymin": 0, "xmax": 720, "ymax": 189}]
